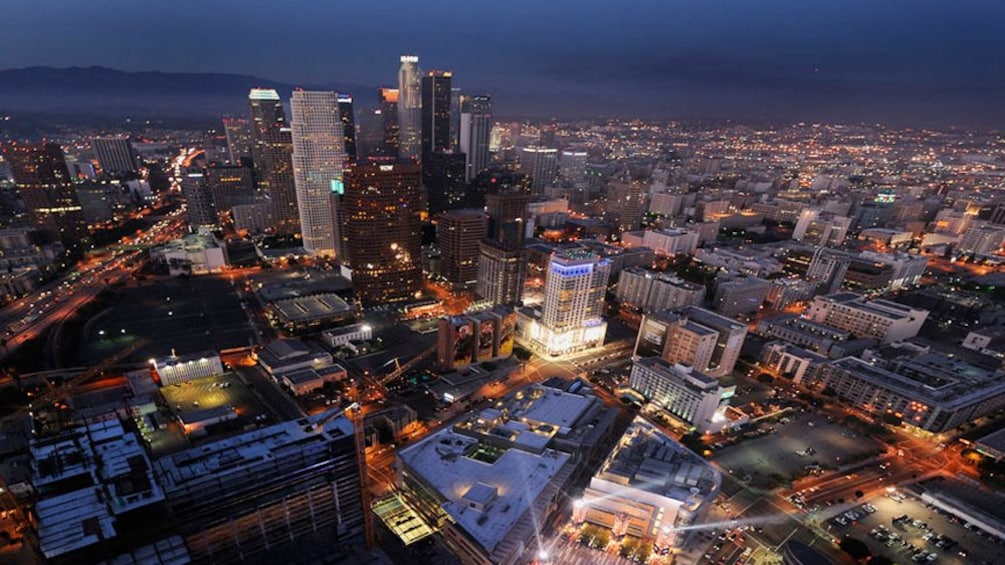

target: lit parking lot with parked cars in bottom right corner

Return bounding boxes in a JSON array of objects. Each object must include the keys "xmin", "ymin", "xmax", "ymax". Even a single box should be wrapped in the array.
[{"xmin": 824, "ymin": 492, "xmax": 1005, "ymax": 565}]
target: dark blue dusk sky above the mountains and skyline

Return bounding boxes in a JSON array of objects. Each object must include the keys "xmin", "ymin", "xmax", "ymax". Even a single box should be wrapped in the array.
[{"xmin": 0, "ymin": 0, "xmax": 1005, "ymax": 127}]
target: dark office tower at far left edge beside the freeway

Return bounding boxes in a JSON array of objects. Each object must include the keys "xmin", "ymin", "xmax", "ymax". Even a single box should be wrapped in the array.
[{"xmin": 3, "ymin": 142, "xmax": 87, "ymax": 250}]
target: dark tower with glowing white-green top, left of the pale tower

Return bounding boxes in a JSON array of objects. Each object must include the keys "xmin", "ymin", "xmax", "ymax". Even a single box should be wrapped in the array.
[{"xmin": 248, "ymin": 88, "xmax": 300, "ymax": 231}]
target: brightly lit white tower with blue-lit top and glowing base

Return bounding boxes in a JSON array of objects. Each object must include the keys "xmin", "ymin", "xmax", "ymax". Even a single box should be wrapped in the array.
[{"xmin": 517, "ymin": 248, "xmax": 611, "ymax": 355}]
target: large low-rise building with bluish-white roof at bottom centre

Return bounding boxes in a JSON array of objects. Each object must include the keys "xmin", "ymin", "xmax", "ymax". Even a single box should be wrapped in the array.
[{"xmin": 397, "ymin": 381, "xmax": 616, "ymax": 565}]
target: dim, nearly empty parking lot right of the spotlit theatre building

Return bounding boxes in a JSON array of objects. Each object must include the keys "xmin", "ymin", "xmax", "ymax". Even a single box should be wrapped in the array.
[{"xmin": 714, "ymin": 412, "xmax": 882, "ymax": 485}]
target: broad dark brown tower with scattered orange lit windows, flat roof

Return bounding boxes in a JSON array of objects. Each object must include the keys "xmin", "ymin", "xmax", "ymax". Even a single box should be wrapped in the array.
[{"xmin": 342, "ymin": 163, "xmax": 422, "ymax": 306}]
